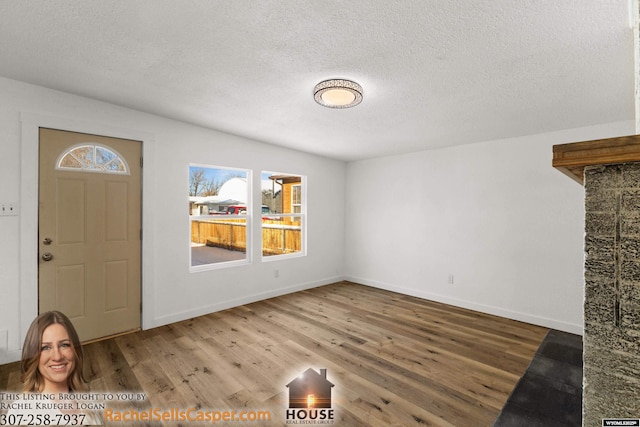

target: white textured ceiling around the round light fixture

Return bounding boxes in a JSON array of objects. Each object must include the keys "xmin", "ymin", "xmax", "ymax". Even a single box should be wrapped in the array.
[{"xmin": 0, "ymin": 0, "xmax": 634, "ymax": 160}]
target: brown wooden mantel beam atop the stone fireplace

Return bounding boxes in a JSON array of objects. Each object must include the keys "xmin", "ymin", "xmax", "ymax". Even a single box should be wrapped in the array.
[{"xmin": 553, "ymin": 135, "xmax": 640, "ymax": 185}]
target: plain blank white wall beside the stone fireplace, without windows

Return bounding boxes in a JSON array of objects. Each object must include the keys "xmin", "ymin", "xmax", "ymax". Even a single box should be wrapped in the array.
[{"xmin": 345, "ymin": 121, "xmax": 634, "ymax": 333}]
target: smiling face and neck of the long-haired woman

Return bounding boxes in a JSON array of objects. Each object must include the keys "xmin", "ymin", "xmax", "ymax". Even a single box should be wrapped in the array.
[{"xmin": 38, "ymin": 323, "xmax": 75, "ymax": 392}]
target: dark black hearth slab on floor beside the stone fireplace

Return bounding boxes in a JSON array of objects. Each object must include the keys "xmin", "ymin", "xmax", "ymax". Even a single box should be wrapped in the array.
[{"xmin": 494, "ymin": 330, "xmax": 582, "ymax": 427}]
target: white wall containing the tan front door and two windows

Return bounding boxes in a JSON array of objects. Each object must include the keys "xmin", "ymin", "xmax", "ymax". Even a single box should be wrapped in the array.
[{"xmin": 0, "ymin": 78, "xmax": 346, "ymax": 363}]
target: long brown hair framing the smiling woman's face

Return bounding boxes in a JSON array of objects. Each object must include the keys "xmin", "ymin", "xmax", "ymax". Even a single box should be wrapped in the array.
[{"xmin": 21, "ymin": 311, "xmax": 87, "ymax": 393}]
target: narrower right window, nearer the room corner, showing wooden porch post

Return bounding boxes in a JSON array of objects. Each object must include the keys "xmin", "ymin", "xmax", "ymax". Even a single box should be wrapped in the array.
[{"xmin": 262, "ymin": 172, "xmax": 305, "ymax": 257}]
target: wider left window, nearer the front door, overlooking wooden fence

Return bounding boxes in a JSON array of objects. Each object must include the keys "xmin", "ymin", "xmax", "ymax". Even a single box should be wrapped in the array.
[{"xmin": 189, "ymin": 165, "xmax": 250, "ymax": 270}]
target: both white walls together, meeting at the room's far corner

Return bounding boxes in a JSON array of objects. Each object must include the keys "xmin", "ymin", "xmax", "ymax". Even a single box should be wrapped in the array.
[{"xmin": 0, "ymin": 73, "xmax": 634, "ymax": 363}]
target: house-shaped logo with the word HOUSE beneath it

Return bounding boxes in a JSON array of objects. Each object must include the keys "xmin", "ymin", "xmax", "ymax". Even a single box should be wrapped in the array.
[{"xmin": 286, "ymin": 368, "xmax": 334, "ymax": 424}]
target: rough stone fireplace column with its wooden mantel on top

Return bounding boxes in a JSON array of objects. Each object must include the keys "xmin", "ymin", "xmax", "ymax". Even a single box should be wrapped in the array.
[{"xmin": 553, "ymin": 135, "xmax": 640, "ymax": 426}]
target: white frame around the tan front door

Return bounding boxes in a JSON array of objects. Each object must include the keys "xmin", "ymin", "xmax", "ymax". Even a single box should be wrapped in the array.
[{"xmin": 18, "ymin": 112, "xmax": 155, "ymax": 347}]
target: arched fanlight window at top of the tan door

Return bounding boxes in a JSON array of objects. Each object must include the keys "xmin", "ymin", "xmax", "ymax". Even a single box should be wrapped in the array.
[{"xmin": 56, "ymin": 143, "xmax": 129, "ymax": 175}]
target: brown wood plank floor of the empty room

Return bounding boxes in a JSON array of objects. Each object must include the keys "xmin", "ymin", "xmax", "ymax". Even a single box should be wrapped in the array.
[{"xmin": 0, "ymin": 282, "xmax": 548, "ymax": 427}]
